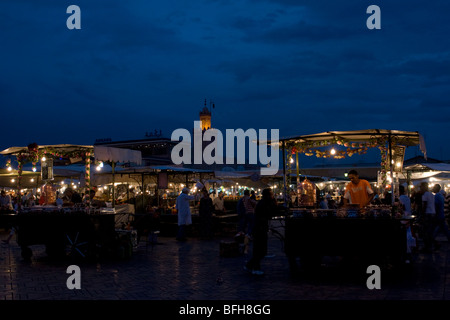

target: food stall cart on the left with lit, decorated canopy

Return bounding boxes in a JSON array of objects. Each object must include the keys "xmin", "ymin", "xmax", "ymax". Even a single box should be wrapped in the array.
[{"xmin": 0, "ymin": 143, "xmax": 141, "ymax": 260}]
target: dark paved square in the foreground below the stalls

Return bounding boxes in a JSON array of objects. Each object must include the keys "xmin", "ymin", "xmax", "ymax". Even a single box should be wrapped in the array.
[{"xmin": 0, "ymin": 222, "xmax": 450, "ymax": 300}]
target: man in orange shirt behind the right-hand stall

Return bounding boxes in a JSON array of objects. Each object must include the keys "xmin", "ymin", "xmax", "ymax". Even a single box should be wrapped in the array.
[{"xmin": 344, "ymin": 170, "xmax": 375, "ymax": 208}]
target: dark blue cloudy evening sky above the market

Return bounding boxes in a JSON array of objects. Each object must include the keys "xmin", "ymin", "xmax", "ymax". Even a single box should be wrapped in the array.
[{"xmin": 0, "ymin": 0, "xmax": 450, "ymax": 164}]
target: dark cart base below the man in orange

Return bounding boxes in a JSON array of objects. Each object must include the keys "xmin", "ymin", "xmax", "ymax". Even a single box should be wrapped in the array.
[{"xmin": 284, "ymin": 211, "xmax": 407, "ymax": 268}]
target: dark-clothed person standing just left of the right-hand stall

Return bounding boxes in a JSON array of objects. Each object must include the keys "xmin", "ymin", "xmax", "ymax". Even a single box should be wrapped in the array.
[{"xmin": 244, "ymin": 188, "xmax": 277, "ymax": 275}]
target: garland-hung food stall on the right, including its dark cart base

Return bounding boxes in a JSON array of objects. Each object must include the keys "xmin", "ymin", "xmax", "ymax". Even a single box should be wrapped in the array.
[{"xmin": 268, "ymin": 129, "xmax": 426, "ymax": 267}]
